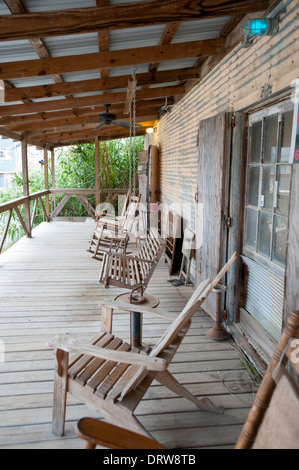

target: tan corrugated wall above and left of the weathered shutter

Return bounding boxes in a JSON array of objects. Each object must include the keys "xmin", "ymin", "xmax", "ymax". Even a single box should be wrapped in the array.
[{"xmin": 148, "ymin": 0, "xmax": 299, "ymax": 237}]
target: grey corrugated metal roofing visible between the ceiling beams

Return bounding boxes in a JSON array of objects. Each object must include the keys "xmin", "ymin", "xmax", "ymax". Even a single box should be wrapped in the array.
[{"xmin": 0, "ymin": 4, "xmax": 230, "ymax": 87}]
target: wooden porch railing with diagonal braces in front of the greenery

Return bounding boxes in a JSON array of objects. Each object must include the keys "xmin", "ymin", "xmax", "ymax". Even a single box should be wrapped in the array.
[{"xmin": 0, "ymin": 188, "xmax": 128, "ymax": 253}]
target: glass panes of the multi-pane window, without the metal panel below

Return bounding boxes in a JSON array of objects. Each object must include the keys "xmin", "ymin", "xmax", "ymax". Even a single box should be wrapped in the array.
[{"xmin": 245, "ymin": 104, "xmax": 293, "ymax": 267}]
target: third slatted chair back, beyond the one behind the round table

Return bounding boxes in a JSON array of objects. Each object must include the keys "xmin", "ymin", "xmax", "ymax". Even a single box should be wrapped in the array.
[{"xmin": 87, "ymin": 196, "xmax": 140, "ymax": 260}]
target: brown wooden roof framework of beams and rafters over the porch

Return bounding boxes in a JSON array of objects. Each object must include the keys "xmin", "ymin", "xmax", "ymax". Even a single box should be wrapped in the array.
[{"xmin": 0, "ymin": 0, "xmax": 277, "ymax": 148}]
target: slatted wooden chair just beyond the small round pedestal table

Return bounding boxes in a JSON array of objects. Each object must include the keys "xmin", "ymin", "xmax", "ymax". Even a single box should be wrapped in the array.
[{"xmin": 99, "ymin": 230, "xmax": 165, "ymax": 296}]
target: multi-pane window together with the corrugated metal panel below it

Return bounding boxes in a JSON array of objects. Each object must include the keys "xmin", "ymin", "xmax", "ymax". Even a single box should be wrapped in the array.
[{"xmin": 242, "ymin": 102, "xmax": 293, "ymax": 340}]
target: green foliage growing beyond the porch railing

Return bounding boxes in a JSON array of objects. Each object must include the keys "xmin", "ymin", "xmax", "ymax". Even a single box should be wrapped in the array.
[{"xmin": 0, "ymin": 136, "xmax": 144, "ymax": 250}]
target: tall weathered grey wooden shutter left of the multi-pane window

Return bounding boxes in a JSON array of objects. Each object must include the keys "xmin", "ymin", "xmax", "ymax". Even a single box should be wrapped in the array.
[{"xmin": 196, "ymin": 113, "xmax": 231, "ymax": 317}]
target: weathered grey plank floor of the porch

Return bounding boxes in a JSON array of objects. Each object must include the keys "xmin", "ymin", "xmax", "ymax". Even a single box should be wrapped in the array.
[{"xmin": 0, "ymin": 221, "xmax": 254, "ymax": 449}]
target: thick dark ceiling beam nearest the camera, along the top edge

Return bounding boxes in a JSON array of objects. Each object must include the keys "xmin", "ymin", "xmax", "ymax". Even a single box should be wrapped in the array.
[{"xmin": 0, "ymin": 0, "xmax": 269, "ymax": 41}]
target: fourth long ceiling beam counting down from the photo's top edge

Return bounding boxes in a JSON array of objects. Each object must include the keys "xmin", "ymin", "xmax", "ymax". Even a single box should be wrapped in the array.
[{"xmin": 0, "ymin": 86, "xmax": 184, "ymax": 116}]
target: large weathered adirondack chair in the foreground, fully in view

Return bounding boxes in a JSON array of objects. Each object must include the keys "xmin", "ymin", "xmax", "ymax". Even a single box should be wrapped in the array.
[{"xmin": 52, "ymin": 254, "xmax": 236, "ymax": 437}]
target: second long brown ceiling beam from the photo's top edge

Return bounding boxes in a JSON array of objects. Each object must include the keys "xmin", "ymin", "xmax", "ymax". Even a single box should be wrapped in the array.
[{"xmin": 0, "ymin": 39, "xmax": 225, "ymax": 80}]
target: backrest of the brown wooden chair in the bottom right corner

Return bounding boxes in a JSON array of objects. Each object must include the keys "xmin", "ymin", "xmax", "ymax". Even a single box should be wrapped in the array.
[{"xmin": 235, "ymin": 311, "xmax": 299, "ymax": 449}]
